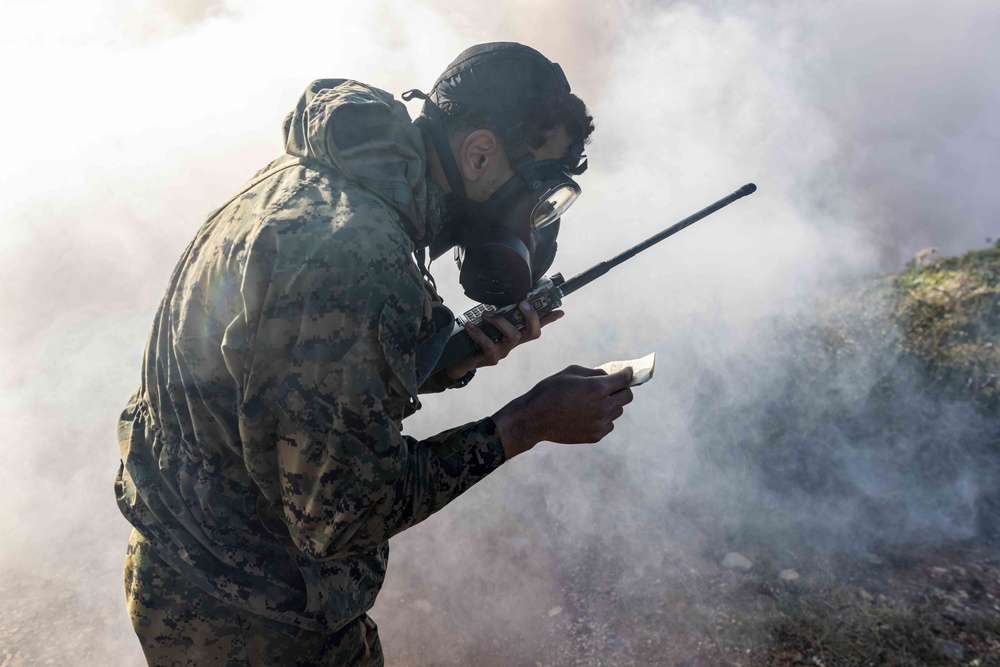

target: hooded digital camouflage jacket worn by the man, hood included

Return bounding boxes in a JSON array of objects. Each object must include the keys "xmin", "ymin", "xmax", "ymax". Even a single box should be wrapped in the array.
[{"xmin": 115, "ymin": 80, "xmax": 504, "ymax": 630}]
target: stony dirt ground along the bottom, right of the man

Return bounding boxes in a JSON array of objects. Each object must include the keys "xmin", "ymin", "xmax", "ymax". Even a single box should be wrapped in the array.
[{"xmin": 383, "ymin": 535, "xmax": 1000, "ymax": 667}]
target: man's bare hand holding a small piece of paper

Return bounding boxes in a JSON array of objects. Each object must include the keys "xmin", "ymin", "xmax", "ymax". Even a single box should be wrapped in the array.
[{"xmin": 493, "ymin": 366, "xmax": 632, "ymax": 459}]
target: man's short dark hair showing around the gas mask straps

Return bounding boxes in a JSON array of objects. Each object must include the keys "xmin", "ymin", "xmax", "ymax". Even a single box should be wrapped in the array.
[{"xmin": 440, "ymin": 91, "xmax": 594, "ymax": 149}]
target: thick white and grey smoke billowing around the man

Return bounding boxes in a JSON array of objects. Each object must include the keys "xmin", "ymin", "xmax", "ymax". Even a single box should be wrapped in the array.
[{"xmin": 0, "ymin": 0, "xmax": 1000, "ymax": 665}]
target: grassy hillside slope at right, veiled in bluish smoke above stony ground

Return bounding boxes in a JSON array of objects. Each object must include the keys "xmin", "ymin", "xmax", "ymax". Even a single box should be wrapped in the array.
[{"xmin": 692, "ymin": 247, "xmax": 1000, "ymax": 549}]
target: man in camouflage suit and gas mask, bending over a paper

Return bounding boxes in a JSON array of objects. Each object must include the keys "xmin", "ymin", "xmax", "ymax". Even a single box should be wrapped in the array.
[{"xmin": 115, "ymin": 43, "xmax": 632, "ymax": 666}]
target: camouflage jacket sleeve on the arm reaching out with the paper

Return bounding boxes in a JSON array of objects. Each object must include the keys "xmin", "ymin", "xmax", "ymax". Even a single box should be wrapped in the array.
[{"xmin": 241, "ymin": 188, "xmax": 504, "ymax": 559}]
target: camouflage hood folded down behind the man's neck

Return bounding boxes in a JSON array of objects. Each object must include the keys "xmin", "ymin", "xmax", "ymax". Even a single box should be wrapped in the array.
[{"xmin": 283, "ymin": 79, "xmax": 442, "ymax": 247}]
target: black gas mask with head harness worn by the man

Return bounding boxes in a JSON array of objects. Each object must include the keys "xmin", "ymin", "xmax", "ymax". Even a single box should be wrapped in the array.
[{"xmin": 403, "ymin": 42, "xmax": 589, "ymax": 306}]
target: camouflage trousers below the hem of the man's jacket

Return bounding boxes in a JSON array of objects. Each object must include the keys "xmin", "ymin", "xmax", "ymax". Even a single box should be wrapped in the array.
[{"xmin": 125, "ymin": 530, "xmax": 383, "ymax": 667}]
